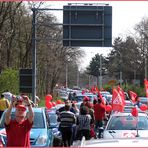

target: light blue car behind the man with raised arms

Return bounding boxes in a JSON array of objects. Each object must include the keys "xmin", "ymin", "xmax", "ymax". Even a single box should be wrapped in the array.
[{"xmin": 0, "ymin": 108, "xmax": 53, "ymax": 147}]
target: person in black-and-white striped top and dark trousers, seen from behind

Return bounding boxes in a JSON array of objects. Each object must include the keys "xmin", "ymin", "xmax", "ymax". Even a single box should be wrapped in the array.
[{"xmin": 58, "ymin": 104, "xmax": 76, "ymax": 147}]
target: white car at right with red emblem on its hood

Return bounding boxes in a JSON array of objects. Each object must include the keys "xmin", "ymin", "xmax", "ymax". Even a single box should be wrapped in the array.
[{"xmin": 103, "ymin": 112, "xmax": 148, "ymax": 139}]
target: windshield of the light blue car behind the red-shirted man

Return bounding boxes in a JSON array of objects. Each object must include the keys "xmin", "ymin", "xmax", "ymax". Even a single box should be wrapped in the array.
[{"xmin": 0, "ymin": 112, "xmax": 45, "ymax": 128}]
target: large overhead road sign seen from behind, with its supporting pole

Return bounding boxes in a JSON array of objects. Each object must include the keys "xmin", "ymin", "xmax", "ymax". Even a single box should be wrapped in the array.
[{"xmin": 28, "ymin": 3, "xmax": 112, "ymax": 102}]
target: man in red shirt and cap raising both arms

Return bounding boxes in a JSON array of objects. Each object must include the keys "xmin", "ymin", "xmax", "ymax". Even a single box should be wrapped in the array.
[{"xmin": 4, "ymin": 96, "xmax": 34, "ymax": 147}]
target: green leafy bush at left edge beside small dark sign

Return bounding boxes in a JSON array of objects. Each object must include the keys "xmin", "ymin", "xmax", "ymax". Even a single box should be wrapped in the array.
[{"xmin": 0, "ymin": 69, "xmax": 19, "ymax": 94}]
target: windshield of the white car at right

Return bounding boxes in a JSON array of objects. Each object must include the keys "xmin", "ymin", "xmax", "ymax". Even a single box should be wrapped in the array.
[{"xmin": 107, "ymin": 116, "xmax": 148, "ymax": 130}]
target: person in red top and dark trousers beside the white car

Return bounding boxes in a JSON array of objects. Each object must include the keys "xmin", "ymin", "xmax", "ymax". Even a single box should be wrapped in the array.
[{"xmin": 94, "ymin": 99, "xmax": 106, "ymax": 139}]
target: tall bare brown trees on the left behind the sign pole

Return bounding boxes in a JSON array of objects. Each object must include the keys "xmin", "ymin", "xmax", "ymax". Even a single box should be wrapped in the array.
[{"xmin": 0, "ymin": 2, "xmax": 83, "ymax": 97}]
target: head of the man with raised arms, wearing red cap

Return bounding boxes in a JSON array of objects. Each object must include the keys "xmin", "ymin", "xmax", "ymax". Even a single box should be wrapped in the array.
[{"xmin": 15, "ymin": 104, "xmax": 27, "ymax": 121}]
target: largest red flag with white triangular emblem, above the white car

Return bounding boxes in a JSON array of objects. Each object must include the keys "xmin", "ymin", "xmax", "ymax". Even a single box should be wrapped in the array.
[{"xmin": 112, "ymin": 88, "xmax": 124, "ymax": 112}]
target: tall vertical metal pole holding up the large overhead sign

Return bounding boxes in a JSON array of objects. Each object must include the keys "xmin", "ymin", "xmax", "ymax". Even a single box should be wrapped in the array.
[{"xmin": 32, "ymin": 8, "xmax": 36, "ymax": 104}]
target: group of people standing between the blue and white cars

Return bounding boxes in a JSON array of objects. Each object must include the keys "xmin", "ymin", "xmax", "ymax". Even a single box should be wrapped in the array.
[{"xmin": 57, "ymin": 97, "xmax": 106, "ymax": 147}]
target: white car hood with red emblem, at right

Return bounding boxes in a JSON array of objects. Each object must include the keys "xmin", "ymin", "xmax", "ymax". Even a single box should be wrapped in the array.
[{"xmin": 103, "ymin": 130, "xmax": 148, "ymax": 139}]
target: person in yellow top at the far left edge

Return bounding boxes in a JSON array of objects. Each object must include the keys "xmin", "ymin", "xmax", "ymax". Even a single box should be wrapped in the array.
[{"xmin": 0, "ymin": 94, "xmax": 10, "ymax": 118}]
